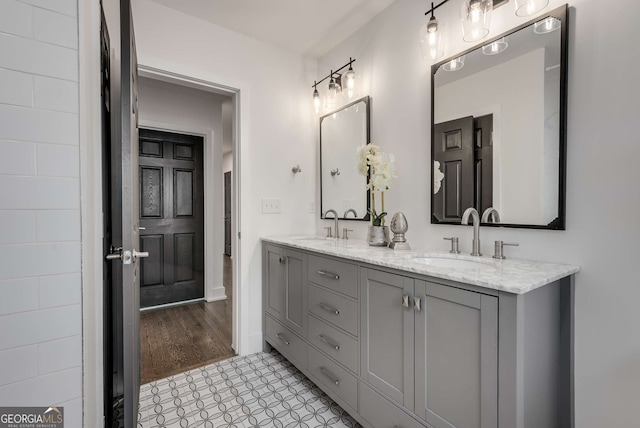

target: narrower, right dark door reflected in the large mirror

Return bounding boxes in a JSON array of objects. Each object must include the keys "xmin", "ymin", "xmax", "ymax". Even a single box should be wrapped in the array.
[{"xmin": 473, "ymin": 114, "xmax": 493, "ymax": 215}]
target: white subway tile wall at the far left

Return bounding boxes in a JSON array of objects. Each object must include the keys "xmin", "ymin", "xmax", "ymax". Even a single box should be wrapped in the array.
[{"xmin": 0, "ymin": 0, "xmax": 82, "ymax": 426}]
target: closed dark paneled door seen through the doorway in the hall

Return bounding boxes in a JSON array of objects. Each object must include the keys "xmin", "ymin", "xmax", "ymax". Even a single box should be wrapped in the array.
[{"xmin": 139, "ymin": 129, "xmax": 204, "ymax": 308}]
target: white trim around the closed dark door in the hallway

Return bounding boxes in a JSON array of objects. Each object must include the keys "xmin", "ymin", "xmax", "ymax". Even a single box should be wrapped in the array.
[{"xmin": 139, "ymin": 119, "xmax": 222, "ymax": 304}]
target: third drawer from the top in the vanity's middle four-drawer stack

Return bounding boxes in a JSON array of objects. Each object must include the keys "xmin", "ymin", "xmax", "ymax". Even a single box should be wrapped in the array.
[{"xmin": 309, "ymin": 316, "xmax": 360, "ymax": 374}]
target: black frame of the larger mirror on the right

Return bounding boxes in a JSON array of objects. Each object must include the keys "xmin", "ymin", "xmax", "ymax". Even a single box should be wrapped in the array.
[{"xmin": 429, "ymin": 4, "xmax": 569, "ymax": 230}]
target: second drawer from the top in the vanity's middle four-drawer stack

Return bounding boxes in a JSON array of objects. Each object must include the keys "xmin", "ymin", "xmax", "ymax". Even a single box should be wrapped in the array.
[{"xmin": 309, "ymin": 284, "xmax": 358, "ymax": 336}]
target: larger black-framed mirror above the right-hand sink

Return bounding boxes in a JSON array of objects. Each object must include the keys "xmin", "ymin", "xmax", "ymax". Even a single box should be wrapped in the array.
[{"xmin": 431, "ymin": 5, "xmax": 568, "ymax": 230}]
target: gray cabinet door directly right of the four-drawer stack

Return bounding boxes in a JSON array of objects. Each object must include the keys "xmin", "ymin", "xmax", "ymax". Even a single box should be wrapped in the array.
[{"xmin": 360, "ymin": 268, "xmax": 414, "ymax": 410}]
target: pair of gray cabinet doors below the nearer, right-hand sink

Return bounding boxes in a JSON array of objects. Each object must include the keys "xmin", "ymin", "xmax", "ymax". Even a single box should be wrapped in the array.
[{"xmin": 360, "ymin": 268, "xmax": 498, "ymax": 428}]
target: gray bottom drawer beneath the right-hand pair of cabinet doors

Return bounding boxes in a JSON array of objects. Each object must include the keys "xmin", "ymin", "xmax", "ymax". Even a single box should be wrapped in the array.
[{"xmin": 358, "ymin": 382, "xmax": 423, "ymax": 428}]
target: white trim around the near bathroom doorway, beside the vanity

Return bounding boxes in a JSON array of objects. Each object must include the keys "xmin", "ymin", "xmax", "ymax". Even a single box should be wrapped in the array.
[{"xmin": 138, "ymin": 64, "xmax": 242, "ymax": 355}]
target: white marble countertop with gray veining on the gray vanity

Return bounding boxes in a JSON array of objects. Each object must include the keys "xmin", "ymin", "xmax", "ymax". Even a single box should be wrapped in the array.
[{"xmin": 262, "ymin": 236, "xmax": 580, "ymax": 294}]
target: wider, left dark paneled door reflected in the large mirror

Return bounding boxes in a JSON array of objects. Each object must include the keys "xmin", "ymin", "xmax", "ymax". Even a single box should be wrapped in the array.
[{"xmin": 433, "ymin": 116, "xmax": 475, "ymax": 223}]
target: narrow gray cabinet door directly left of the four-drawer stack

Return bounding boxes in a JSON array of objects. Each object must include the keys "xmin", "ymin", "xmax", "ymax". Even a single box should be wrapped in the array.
[{"xmin": 283, "ymin": 249, "xmax": 307, "ymax": 338}]
